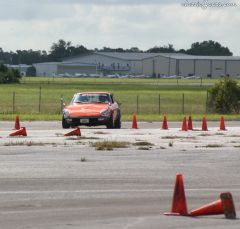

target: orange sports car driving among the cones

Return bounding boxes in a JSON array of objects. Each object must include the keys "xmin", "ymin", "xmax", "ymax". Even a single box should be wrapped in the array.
[{"xmin": 62, "ymin": 92, "xmax": 121, "ymax": 129}]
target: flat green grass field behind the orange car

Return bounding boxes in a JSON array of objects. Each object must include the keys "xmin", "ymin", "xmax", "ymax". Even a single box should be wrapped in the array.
[{"xmin": 0, "ymin": 77, "xmax": 240, "ymax": 121}]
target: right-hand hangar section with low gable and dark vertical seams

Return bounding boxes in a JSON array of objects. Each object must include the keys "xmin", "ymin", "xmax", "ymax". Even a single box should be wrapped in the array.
[{"xmin": 143, "ymin": 54, "xmax": 240, "ymax": 78}]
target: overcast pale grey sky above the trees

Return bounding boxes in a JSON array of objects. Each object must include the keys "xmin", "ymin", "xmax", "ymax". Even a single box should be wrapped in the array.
[{"xmin": 0, "ymin": 0, "xmax": 240, "ymax": 56}]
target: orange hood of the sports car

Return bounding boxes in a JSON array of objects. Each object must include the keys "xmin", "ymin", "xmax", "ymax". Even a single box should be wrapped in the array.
[{"xmin": 64, "ymin": 103, "xmax": 109, "ymax": 117}]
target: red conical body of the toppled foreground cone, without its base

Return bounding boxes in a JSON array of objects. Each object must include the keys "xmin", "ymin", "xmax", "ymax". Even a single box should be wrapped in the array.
[{"xmin": 190, "ymin": 199, "xmax": 224, "ymax": 216}]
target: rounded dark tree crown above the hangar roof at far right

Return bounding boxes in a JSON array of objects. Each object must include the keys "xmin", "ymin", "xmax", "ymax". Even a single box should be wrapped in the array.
[{"xmin": 186, "ymin": 40, "xmax": 232, "ymax": 56}]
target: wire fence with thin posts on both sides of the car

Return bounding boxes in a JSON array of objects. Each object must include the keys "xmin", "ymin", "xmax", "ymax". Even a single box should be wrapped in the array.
[{"xmin": 0, "ymin": 87, "xmax": 208, "ymax": 114}]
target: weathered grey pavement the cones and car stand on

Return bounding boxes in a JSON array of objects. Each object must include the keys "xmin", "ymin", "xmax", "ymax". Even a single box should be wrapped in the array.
[{"xmin": 0, "ymin": 122, "xmax": 240, "ymax": 229}]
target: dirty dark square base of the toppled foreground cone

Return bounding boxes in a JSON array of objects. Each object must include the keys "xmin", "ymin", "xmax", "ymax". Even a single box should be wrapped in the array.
[{"xmin": 220, "ymin": 192, "xmax": 236, "ymax": 219}]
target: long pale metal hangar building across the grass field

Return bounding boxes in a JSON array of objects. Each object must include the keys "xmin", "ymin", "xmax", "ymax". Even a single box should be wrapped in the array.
[{"xmin": 34, "ymin": 52, "xmax": 240, "ymax": 78}]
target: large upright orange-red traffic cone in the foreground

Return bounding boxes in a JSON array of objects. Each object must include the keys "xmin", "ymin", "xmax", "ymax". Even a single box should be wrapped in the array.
[{"xmin": 164, "ymin": 174, "xmax": 189, "ymax": 216}]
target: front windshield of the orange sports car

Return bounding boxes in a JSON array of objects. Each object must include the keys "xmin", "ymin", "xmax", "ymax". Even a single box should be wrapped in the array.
[{"xmin": 73, "ymin": 93, "xmax": 110, "ymax": 103}]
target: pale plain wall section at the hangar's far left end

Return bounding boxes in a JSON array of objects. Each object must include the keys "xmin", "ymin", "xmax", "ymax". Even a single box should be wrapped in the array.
[{"xmin": 33, "ymin": 62, "xmax": 58, "ymax": 76}]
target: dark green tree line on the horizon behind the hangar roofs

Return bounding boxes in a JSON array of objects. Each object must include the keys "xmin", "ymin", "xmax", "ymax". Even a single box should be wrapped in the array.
[{"xmin": 0, "ymin": 39, "xmax": 233, "ymax": 65}]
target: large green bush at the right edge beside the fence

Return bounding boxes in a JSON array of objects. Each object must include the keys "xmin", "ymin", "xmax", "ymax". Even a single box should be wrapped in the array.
[{"xmin": 208, "ymin": 77, "xmax": 240, "ymax": 114}]
